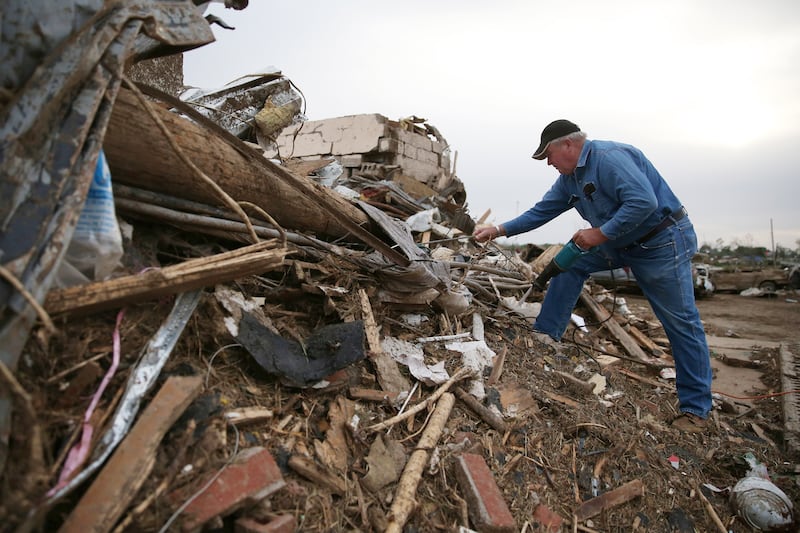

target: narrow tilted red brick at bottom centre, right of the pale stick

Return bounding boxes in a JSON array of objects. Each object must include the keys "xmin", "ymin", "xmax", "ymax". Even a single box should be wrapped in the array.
[{"xmin": 456, "ymin": 453, "xmax": 517, "ymax": 533}]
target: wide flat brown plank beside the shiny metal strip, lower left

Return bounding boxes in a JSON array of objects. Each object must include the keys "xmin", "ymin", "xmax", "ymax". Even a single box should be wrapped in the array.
[{"xmin": 59, "ymin": 376, "xmax": 203, "ymax": 533}]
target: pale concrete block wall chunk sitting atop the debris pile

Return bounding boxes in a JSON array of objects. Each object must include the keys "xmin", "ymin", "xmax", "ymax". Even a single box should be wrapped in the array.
[{"xmin": 266, "ymin": 113, "xmax": 450, "ymax": 185}]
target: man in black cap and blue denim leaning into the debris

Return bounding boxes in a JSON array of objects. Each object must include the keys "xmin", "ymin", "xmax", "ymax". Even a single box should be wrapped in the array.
[{"xmin": 474, "ymin": 119, "xmax": 711, "ymax": 432}]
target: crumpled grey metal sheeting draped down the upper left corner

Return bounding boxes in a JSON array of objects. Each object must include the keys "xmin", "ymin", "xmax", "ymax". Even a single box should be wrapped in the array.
[{"xmin": 0, "ymin": 0, "xmax": 213, "ymax": 482}]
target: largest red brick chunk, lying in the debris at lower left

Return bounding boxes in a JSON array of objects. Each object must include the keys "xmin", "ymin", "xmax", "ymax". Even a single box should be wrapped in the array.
[{"xmin": 183, "ymin": 448, "xmax": 286, "ymax": 531}]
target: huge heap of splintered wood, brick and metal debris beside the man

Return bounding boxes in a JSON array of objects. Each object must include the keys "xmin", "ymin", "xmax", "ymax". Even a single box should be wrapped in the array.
[{"xmin": 0, "ymin": 1, "xmax": 800, "ymax": 532}]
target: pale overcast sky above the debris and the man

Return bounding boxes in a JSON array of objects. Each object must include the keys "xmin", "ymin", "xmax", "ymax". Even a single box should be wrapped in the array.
[{"xmin": 184, "ymin": 0, "xmax": 800, "ymax": 249}]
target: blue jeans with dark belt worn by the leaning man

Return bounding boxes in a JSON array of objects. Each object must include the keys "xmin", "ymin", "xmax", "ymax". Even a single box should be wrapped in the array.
[{"xmin": 533, "ymin": 217, "xmax": 712, "ymax": 418}]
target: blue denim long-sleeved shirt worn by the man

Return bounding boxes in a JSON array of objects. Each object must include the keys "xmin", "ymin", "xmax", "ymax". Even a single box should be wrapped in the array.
[{"xmin": 503, "ymin": 139, "xmax": 681, "ymax": 248}]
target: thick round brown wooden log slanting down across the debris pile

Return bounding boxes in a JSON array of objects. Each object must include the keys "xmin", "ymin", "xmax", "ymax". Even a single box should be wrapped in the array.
[{"xmin": 103, "ymin": 89, "xmax": 367, "ymax": 237}]
